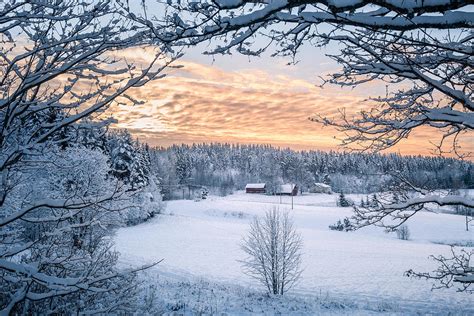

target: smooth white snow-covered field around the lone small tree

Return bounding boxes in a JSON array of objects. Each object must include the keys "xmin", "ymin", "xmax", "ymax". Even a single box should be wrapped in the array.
[{"xmin": 116, "ymin": 192, "xmax": 474, "ymax": 314}]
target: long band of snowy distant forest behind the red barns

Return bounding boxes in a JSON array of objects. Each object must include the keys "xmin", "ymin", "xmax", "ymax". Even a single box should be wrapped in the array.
[{"xmin": 149, "ymin": 143, "xmax": 474, "ymax": 198}]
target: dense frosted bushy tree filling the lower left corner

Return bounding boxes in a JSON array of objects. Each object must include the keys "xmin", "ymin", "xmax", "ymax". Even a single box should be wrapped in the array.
[{"xmin": 0, "ymin": 147, "xmax": 158, "ymax": 313}]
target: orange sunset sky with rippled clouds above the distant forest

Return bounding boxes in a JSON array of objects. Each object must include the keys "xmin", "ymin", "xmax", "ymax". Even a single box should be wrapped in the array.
[{"xmin": 112, "ymin": 47, "xmax": 474, "ymax": 154}]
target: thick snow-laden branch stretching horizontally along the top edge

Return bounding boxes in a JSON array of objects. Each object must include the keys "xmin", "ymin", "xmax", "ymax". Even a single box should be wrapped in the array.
[{"xmin": 155, "ymin": 0, "xmax": 474, "ymax": 53}]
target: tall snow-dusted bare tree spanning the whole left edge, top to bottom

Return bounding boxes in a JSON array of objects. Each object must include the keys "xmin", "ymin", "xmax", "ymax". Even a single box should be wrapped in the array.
[{"xmin": 0, "ymin": 0, "xmax": 174, "ymax": 314}]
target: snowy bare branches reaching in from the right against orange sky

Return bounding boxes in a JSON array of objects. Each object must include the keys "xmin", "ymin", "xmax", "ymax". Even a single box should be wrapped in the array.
[{"xmin": 312, "ymin": 31, "xmax": 474, "ymax": 158}]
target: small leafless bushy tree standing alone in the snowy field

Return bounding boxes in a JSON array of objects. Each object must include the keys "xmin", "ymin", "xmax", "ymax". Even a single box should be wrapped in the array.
[{"xmin": 242, "ymin": 208, "xmax": 302, "ymax": 295}]
